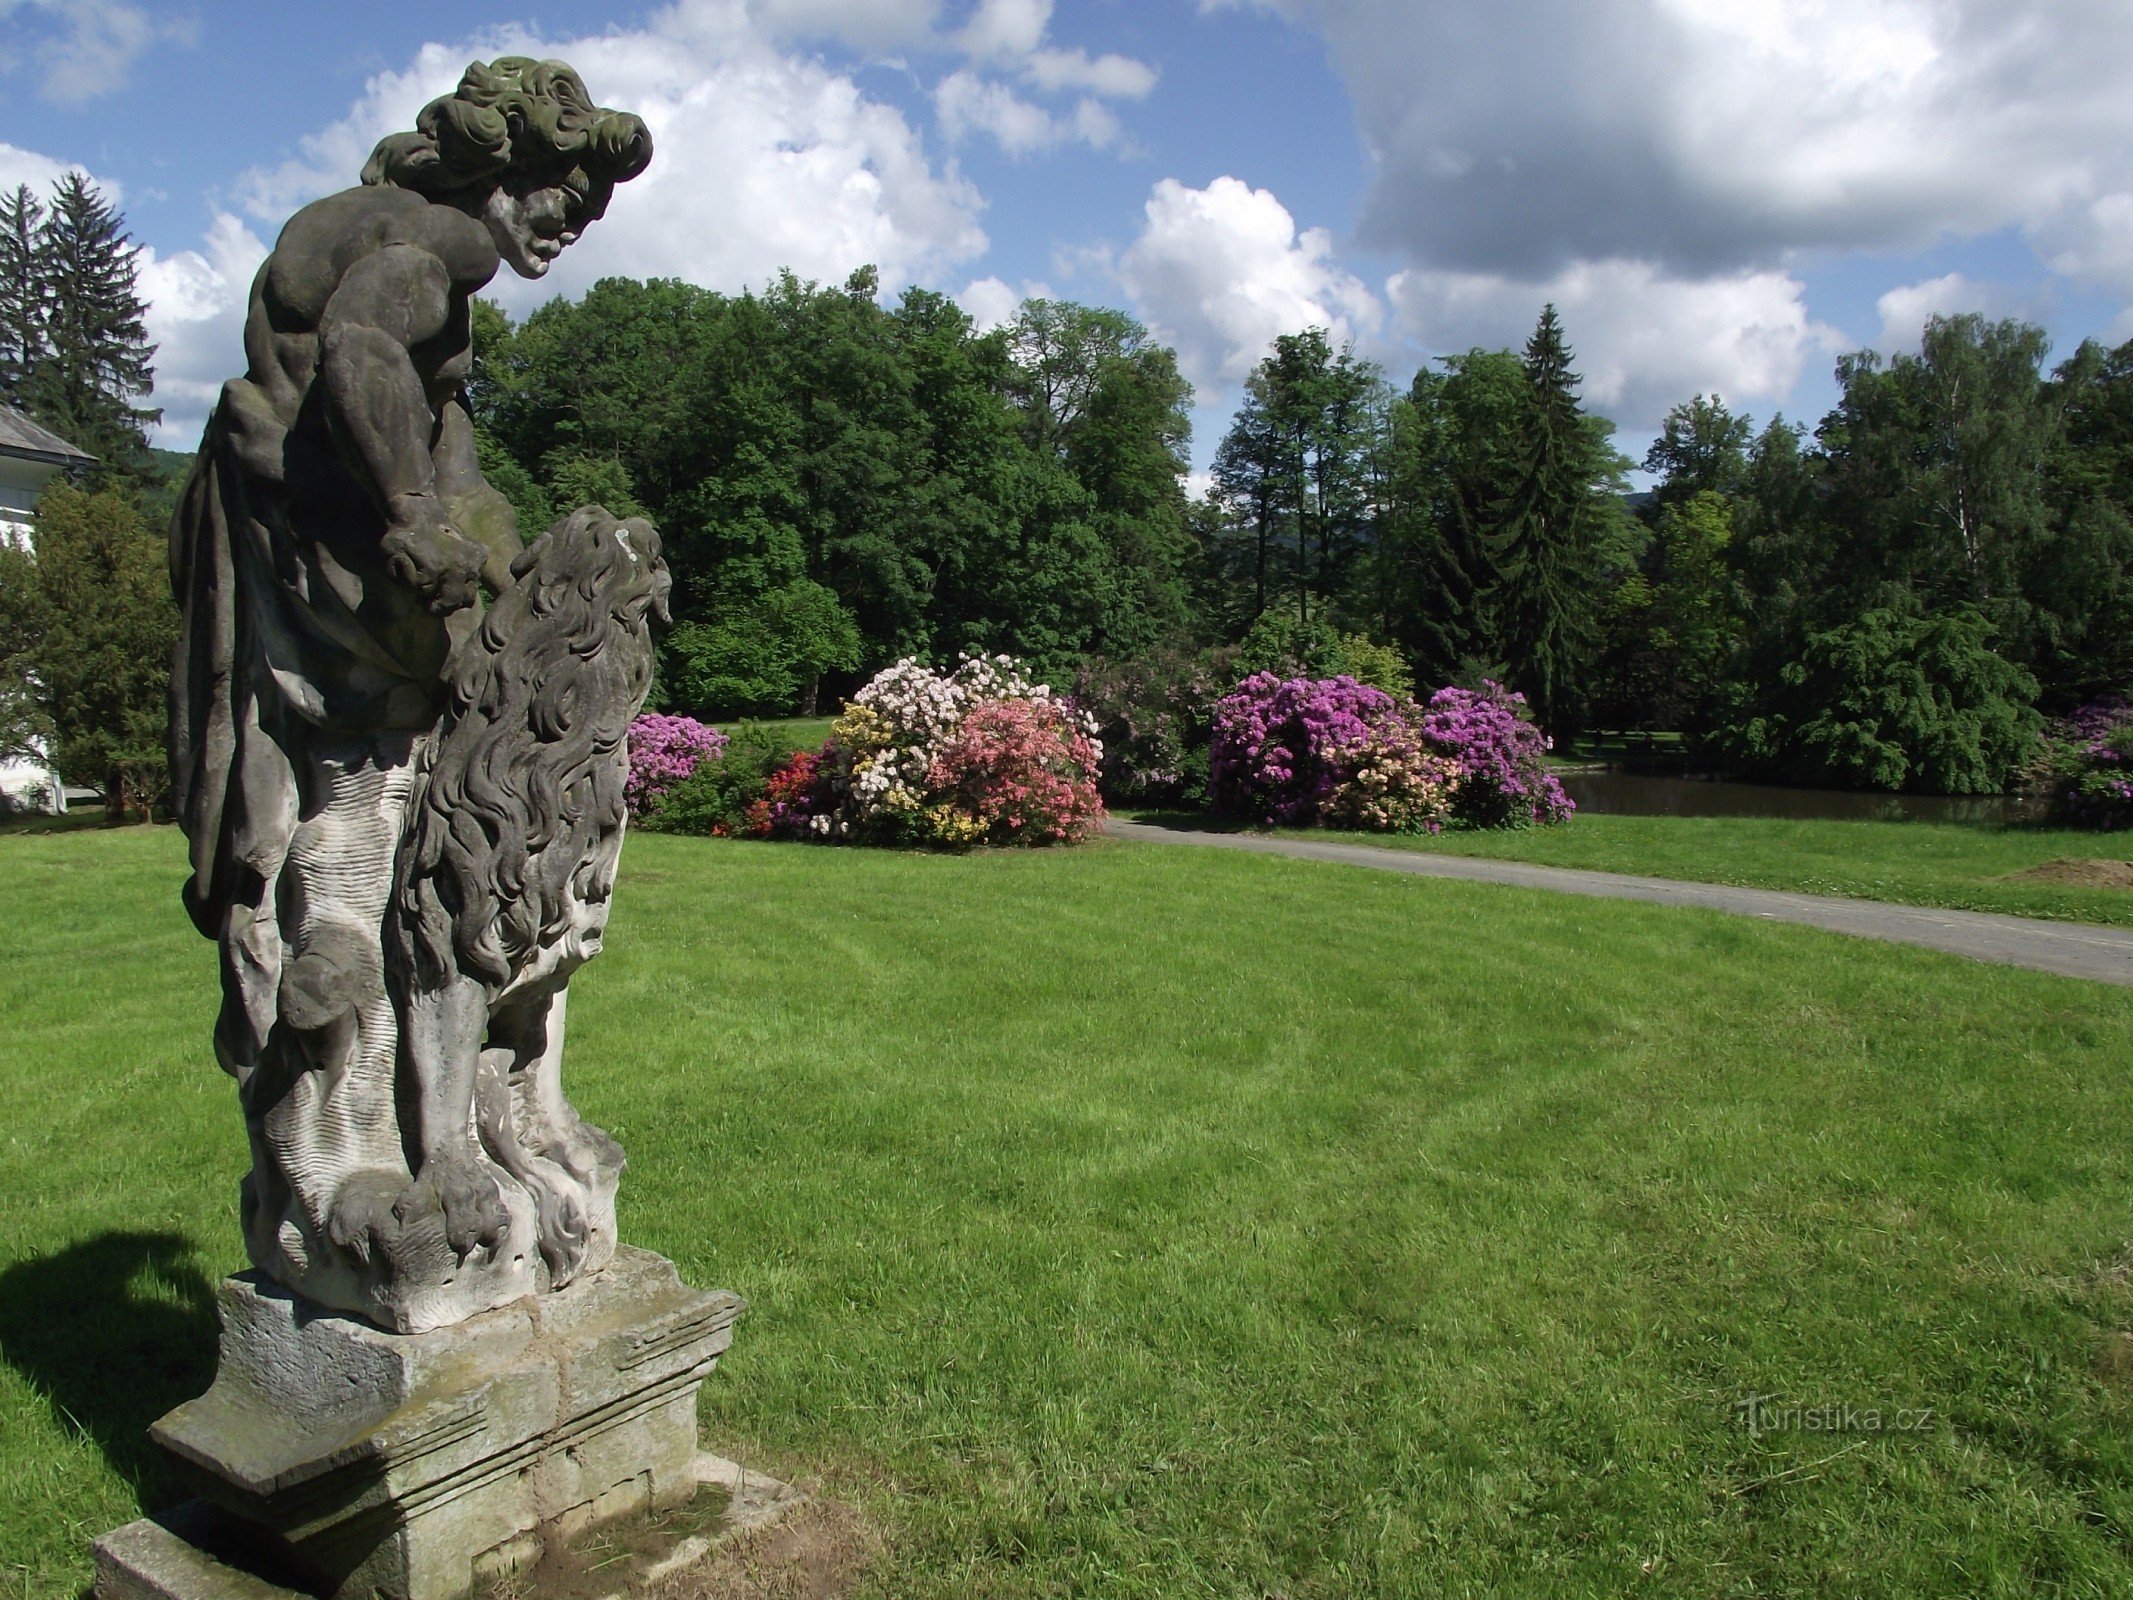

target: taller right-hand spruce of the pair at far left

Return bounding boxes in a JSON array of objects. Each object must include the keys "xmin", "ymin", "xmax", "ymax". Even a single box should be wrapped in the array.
[{"xmin": 28, "ymin": 173, "xmax": 162, "ymax": 471}]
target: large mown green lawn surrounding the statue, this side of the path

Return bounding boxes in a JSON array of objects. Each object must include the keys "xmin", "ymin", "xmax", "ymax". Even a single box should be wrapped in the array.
[{"xmin": 0, "ymin": 830, "xmax": 2133, "ymax": 1600}]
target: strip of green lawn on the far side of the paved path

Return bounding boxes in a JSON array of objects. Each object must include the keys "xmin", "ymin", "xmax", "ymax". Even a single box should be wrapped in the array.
[{"xmin": 1120, "ymin": 811, "xmax": 2133, "ymax": 926}]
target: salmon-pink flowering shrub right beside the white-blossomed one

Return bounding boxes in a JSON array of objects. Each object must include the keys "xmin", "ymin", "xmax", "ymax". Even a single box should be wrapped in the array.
[{"xmin": 926, "ymin": 700, "xmax": 1103, "ymax": 845}]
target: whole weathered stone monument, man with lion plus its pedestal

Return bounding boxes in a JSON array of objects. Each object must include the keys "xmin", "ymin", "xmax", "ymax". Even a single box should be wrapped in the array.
[{"xmin": 96, "ymin": 58, "xmax": 793, "ymax": 1600}]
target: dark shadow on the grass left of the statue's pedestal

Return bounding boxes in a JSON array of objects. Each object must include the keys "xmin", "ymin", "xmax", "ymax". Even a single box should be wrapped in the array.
[{"xmin": 0, "ymin": 1233, "xmax": 215, "ymax": 1508}]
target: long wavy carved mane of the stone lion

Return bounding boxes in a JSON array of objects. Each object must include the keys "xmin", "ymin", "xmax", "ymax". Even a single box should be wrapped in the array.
[{"xmin": 392, "ymin": 506, "xmax": 670, "ymax": 1001}]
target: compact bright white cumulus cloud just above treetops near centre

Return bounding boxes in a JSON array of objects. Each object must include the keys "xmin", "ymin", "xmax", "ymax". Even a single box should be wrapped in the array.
[{"xmin": 1116, "ymin": 177, "xmax": 1382, "ymax": 388}]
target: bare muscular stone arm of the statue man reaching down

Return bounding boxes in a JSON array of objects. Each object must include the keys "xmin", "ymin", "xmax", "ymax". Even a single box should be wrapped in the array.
[{"xmin": 318, "ymin": 243, "xmax": 484, "ymax": 610}]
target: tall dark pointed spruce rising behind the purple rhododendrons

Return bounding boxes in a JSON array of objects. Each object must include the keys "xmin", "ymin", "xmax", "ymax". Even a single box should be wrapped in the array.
[{"xmin": 1489, "ymin": 305, "xmax": 1615, "ymax": 732}]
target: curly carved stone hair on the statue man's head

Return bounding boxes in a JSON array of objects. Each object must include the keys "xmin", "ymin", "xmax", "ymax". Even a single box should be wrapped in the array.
[{"xmin": 363, "ymin": 55, "xmax": 653, "ymax": 205}]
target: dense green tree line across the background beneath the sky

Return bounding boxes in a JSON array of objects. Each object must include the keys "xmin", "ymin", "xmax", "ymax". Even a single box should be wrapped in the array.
[{"xmin": 0, "ymin": 175, "xmax": 2133, "ymax": 806}]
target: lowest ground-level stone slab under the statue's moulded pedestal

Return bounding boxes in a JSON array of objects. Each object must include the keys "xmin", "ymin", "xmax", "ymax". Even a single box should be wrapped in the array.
[{"xmin": 96, "ymin": 1455, "xmax": 806, "ymax": 1600}]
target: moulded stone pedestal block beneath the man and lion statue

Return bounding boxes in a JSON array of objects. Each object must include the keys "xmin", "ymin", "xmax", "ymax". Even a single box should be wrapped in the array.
[{"xmin": 96, "ymin": 1246, "xmax": 742, "ymax": 1600}]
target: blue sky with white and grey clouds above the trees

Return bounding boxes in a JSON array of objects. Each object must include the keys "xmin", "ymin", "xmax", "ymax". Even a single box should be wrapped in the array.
[{"xmin": 0, "ymin": 0, "xmax": 2133, "ymax": 480}]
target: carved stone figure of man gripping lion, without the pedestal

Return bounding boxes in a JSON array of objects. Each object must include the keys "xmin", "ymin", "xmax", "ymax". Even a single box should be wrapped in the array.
[{"xmin": 171, "ymin": 58, "xmax": 668, "ymax": 1333}]
